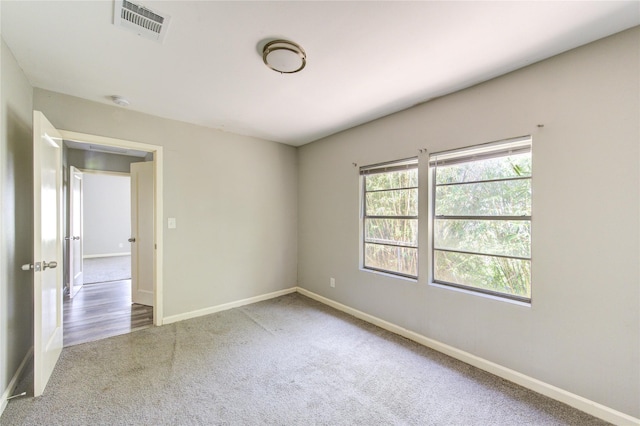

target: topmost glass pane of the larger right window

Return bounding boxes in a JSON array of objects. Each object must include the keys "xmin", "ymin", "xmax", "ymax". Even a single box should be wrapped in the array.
[{"xmin": 436, "ymin": 152, "xmax": 531, "ymax": 185}]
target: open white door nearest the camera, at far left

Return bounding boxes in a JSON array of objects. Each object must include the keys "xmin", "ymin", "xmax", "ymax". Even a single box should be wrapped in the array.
[{"xmin": 28, "ymin": 111, "xmax": 62, "ymax": 396}]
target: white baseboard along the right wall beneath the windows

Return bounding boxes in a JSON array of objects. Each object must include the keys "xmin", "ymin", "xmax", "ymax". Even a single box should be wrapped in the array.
[{"xmin": 297, "ymin": 287, "xmax": 640, "ymax": 425}]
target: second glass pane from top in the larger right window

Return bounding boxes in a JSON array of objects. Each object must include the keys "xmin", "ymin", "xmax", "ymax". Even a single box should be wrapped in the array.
[{"xmin": 436, "ymin": 179, "xmax": 531, "ymax": 216}]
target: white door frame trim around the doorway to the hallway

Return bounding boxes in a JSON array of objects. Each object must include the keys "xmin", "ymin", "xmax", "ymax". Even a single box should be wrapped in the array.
[{"xmin": 58, "ymin": 130, "xmax": 164, "ymax": 326}]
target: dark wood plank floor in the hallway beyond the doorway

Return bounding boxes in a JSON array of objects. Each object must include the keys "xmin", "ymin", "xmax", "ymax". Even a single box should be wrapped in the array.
[{"xmin": 63, "ymin": 280, "xmax": 153, "ymax": 347}]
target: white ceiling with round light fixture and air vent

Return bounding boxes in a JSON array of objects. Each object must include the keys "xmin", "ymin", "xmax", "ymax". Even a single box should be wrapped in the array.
[{"xmin": 0, "ymin": 0, "xmax": 640, "ymax": 146}]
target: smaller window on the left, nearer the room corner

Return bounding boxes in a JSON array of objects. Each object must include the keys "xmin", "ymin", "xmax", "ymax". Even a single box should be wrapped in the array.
[{"xmin": 360, "ymin": 159, "xmax": 418, "ymax": 278}]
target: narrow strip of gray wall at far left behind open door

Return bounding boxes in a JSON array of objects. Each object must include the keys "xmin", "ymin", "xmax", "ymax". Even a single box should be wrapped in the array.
[{"xmin": 0, "ymin": 40, "xmax": 33, "ymax": 410}]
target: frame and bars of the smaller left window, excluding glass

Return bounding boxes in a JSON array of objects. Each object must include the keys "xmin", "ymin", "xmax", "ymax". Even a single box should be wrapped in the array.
[{"xmin": 360, "ymin": 157, "xmax": 420, "ymax": 280}]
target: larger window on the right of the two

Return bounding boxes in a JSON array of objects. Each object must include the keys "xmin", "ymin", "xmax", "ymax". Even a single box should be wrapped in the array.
[{"xmin": 429, "ymin": 137, "xmax": 531, "ymax": 302}]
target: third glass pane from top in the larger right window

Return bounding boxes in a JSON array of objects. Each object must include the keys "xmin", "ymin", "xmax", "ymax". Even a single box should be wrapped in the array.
[{"xmin": 434, "ymin": 219, "xmax": 531, "ymax": 257}]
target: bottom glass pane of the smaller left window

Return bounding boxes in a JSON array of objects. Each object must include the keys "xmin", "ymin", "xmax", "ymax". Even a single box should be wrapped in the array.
[{"xmin": 364, "ymin": 244, "xmax": 418, "ymax": 277}]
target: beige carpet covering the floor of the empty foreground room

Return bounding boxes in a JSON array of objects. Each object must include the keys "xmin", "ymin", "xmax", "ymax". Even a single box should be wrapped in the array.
[{"xmin": 0, "ymin": 294, "xmax": 604, "ymax": 425}]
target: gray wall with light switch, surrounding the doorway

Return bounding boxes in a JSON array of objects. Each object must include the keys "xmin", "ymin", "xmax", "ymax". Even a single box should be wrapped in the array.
[{"xmin": 34, "ymin": 89, "xmax": 297, "ymax": 316}]
